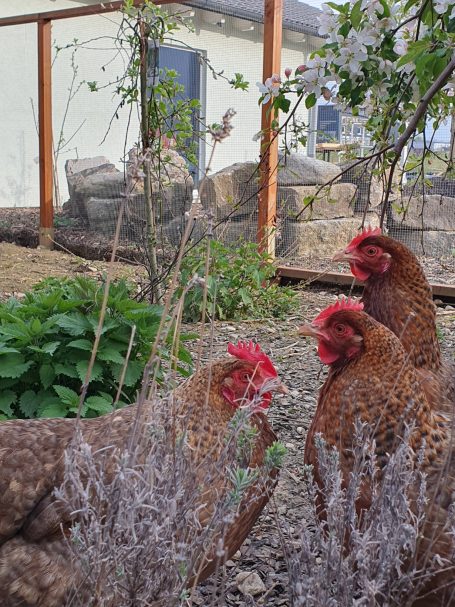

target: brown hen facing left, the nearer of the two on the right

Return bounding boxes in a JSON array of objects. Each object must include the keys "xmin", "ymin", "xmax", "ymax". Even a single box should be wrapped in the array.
[{"xmin": 299, "ymin": 299, "xmax": 455, "ymax": 607}]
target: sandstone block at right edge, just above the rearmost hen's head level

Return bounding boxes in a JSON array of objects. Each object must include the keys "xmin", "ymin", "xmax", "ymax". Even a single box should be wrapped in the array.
[{"xmin": 388, "ymin": 196, "xmax": 455, "ymax": 231}]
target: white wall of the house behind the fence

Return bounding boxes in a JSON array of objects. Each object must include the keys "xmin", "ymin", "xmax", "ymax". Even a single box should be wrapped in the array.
[{"xmin": 0, "ymin": 0, "xmax": 320, "ymax": 207}]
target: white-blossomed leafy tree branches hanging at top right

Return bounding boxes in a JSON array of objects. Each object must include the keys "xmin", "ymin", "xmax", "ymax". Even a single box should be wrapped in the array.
[{"xmin": 258, "ymin": 0, "xmax": 455, "ymax": 197}]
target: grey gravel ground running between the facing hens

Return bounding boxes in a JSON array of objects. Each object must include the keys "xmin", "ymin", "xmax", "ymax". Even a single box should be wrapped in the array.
[{"xmin": 194, "ymin": 289, "xmax": 455, "ymax": 607}]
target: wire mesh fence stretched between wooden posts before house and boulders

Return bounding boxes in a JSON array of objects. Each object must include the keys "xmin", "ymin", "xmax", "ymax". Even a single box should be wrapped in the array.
[{"xmin": 0, "ymin": 0, "xmax": 455, "ymax": 283}]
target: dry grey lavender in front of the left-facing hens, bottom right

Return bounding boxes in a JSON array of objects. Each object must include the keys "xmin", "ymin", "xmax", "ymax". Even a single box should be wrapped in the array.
[{"xmin": 286, "ymin": 422, "xmax": 450, "ymax": 607}]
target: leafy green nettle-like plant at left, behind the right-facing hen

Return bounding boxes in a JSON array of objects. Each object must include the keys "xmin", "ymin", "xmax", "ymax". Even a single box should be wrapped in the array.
[{"xmin": 0, "ymin": 277, "xmax": 191, "ymax": 419}]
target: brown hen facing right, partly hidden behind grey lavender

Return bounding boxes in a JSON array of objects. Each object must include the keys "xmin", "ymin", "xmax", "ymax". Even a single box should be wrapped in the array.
[{"xmin": 0, "ymin": 342, "xmax": 286, "ymax": 607}]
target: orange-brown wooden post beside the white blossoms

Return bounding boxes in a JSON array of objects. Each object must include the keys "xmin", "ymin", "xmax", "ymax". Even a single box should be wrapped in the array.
[{"xmin": 258, "ymin": 0, "xmax": 283, "ymax": 257}]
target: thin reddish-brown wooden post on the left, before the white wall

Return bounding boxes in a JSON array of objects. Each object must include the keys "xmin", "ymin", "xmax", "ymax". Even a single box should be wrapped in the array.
[{"xmin": 38, "ymin": 19, "xmax": 54, "ymax": 249}]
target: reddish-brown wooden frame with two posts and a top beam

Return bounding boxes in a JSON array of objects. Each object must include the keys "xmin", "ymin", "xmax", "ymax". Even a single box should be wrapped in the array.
[{"xmin": 0, "ymin": 0, "xmax": 283, "ymax": 256}]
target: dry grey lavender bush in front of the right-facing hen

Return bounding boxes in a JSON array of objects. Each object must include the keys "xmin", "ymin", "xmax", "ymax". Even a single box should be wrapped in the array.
[{"xmin": 58, "ymin": 397, "xmax": 282, "ymax": 607}]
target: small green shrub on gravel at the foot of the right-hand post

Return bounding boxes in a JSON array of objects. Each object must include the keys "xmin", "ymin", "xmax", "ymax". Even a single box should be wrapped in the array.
[{"xmin": 176, "ymin": 240, "xmax": 297, "ymax": 322}]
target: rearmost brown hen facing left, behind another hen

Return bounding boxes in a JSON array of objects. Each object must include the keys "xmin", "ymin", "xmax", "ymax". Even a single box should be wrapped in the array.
[{"xmin": 333, "ymin": 228, "xmax": 455, "ymax": 411}]
